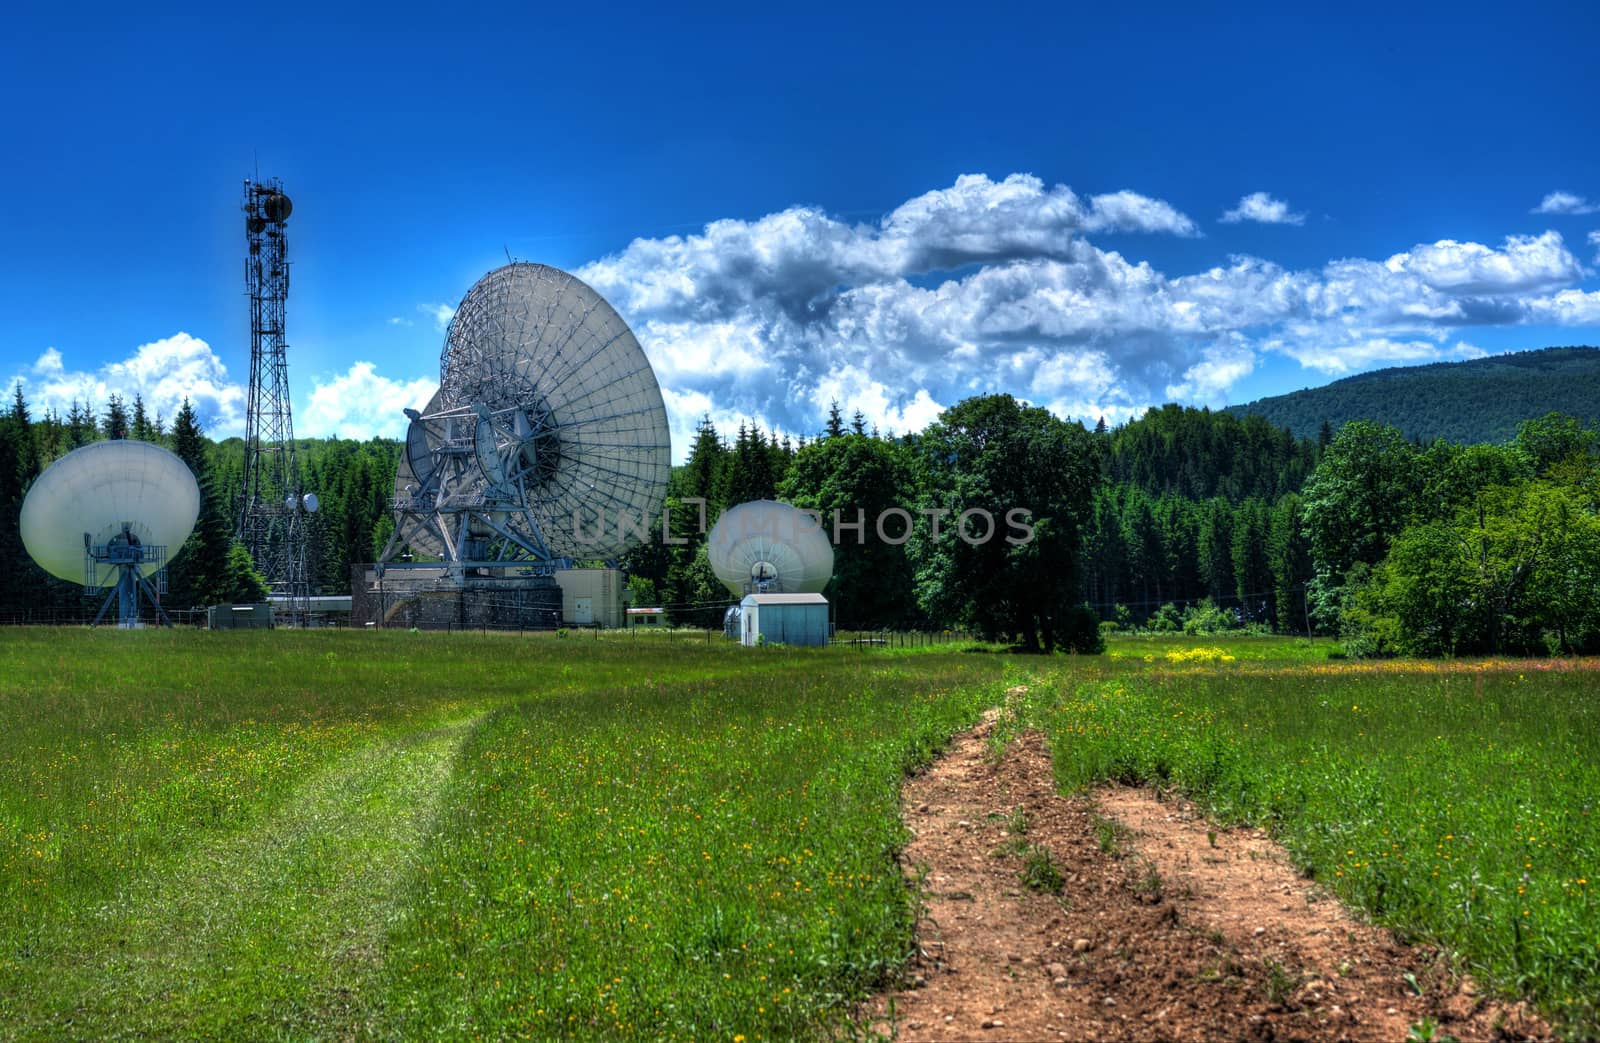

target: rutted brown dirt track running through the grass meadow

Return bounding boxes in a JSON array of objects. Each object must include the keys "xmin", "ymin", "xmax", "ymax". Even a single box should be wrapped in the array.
[{"xmin": 870, "ymin": 723, "xmax": 1549, "ymax": 1041}]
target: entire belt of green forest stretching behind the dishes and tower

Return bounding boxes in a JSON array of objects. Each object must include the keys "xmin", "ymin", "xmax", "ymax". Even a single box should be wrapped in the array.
[{"xmin": 0, "ymin": 372, "xmax": 1600, "ymax": 654}]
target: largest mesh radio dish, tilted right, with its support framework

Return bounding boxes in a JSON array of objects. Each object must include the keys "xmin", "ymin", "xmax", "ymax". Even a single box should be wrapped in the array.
[{"xmin": 384, "ymin": 262, "xmax": 672, "ymax": 565}]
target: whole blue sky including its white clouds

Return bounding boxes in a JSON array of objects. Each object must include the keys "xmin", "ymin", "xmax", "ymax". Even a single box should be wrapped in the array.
[{"xmin": 0, "ymin": 3, "xmax": 1600, "ymax": 456}]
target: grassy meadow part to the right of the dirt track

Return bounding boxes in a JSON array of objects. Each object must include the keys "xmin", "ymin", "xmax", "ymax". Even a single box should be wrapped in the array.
[{"xmin": 1026, "ymin": 643, "xmax": 1600, "ymax": 1038}]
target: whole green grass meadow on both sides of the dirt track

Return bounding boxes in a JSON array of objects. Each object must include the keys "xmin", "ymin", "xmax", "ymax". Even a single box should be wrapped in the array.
[{"xmin": 0, "ymin": 630, "xmax": 1600, "ymax": 1040}]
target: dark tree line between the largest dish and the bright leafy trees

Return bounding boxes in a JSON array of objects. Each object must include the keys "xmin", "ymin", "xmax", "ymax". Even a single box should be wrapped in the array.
[{"xmin": 627, "ymin": 395, "xmax": 1331, "ymax": 648}]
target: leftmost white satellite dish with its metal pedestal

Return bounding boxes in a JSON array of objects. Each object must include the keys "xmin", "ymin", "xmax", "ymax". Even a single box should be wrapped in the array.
[{"xmin": 21, "ymin": 440, "xmax": 200, "ymax": 625}]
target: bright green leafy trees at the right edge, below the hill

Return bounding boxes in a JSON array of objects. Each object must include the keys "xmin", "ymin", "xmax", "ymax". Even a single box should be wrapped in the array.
[{"xmin": 1304, "ymin": 413, "xmax": 1600, "ymax": 656}]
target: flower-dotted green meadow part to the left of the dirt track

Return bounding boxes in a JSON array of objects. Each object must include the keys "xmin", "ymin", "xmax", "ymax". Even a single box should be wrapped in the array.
[{"xmin": 0, "ymin": 630, "xmax": 1003, "ymax": 1040}]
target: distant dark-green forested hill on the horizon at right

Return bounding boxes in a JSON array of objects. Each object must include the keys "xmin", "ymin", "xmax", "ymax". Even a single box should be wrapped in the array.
[{"xmin": 1227, "ymin": 347, "xmax": 1600, "ymax": 445}]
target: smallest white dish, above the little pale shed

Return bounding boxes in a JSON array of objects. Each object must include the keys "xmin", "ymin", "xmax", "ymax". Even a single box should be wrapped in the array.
[{"xmin": 706, "ymin": 499, "xmax": 834, "ymax": 595}]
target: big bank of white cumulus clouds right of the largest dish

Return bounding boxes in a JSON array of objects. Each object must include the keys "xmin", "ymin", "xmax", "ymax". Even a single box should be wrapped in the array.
[{"xmin": 576, "ymin": 174, "xmax": 1595, "ymax": 444}]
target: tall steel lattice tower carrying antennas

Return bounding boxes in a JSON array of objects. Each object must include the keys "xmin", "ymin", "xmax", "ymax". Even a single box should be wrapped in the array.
[{"xmin": 238, "ymin": 178, "xmax": 317, "ymax": 625}]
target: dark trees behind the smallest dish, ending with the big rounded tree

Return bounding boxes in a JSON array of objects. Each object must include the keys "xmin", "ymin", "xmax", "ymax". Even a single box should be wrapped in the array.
[{"xmin": 624, "ymin": 395, "xmax": 1102, "ymax": 651}]
